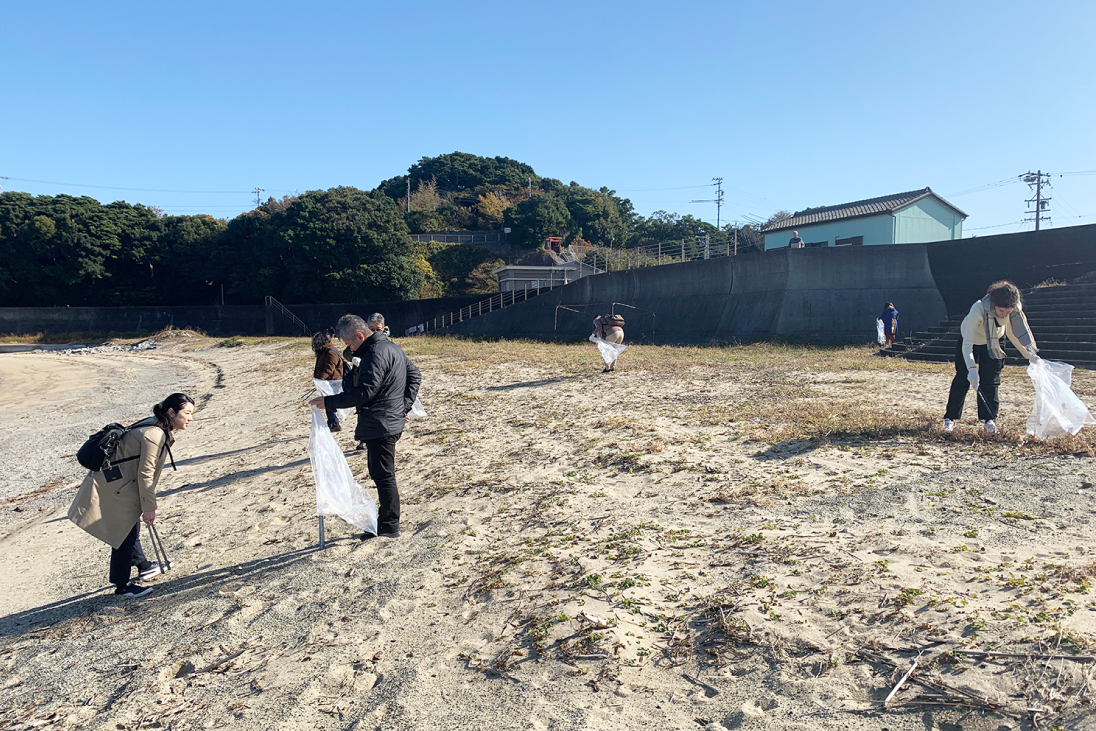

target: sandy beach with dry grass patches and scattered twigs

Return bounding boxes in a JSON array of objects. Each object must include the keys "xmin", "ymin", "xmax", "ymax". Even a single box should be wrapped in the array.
[{"xmin": 0, "ymin": 331, "xmax": 1096, "ymax": 731}]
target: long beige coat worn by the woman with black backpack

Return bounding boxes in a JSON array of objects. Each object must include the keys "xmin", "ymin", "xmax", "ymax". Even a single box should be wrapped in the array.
[{"xmin": 69, "ymin": 416, "xmax": 174, "ymax": 548}]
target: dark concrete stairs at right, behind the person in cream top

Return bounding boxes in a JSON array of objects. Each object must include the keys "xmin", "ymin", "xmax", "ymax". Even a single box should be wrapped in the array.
[{"xmin": 879, "ymin": 273, "xmax": 1096, "ymax": 369}]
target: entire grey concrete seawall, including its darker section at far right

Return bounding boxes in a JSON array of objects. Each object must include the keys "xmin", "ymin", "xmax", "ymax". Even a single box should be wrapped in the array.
[{"xmin": 446, "ymin": 226, "xmax": 1096, "ymax": 344}]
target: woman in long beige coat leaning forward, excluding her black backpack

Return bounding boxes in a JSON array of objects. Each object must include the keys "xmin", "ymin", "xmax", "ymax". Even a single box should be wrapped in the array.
[{"xmin": 69, "ymin": 393, "xmax": 194, "ymax": 598}]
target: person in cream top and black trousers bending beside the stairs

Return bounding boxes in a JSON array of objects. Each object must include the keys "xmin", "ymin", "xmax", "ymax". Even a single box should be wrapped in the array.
[{"xmin": 944, "ymin": 281, "xmax": 1039, "ymax": 434}]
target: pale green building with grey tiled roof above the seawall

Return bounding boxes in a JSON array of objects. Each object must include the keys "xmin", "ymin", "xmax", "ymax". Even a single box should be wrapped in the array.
[{"xmin": 761, "ymin": 187, "xmax": 967, "ymax": 251}]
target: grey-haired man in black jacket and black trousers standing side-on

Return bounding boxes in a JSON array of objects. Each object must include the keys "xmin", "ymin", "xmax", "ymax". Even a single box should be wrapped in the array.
[{"xmin": 310, "ymin": 313, "xmax": 422, "ymax": 540}]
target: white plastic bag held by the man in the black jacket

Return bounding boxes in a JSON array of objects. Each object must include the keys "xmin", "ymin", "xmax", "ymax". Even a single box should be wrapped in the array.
[{"xmin": 308, "ymin": 407, "xmax": 377, "ymax": 534}]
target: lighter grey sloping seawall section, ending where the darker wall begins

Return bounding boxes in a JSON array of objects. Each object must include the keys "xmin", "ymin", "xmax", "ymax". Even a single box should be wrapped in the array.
[{"xmin": 447, "ymin": 244, "xmax": 946, "ymax": 343}]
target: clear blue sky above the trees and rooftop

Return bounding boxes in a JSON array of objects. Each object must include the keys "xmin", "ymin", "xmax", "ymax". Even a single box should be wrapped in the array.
[{"xmin": 0, "ymin": 0, "xmax": 1096, "ymax": 235}]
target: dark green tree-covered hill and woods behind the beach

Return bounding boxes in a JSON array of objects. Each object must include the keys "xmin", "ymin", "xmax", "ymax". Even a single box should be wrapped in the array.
[{"xmin": 0, "ymin": 152, "xmax": 762, "ymax": 307}]
